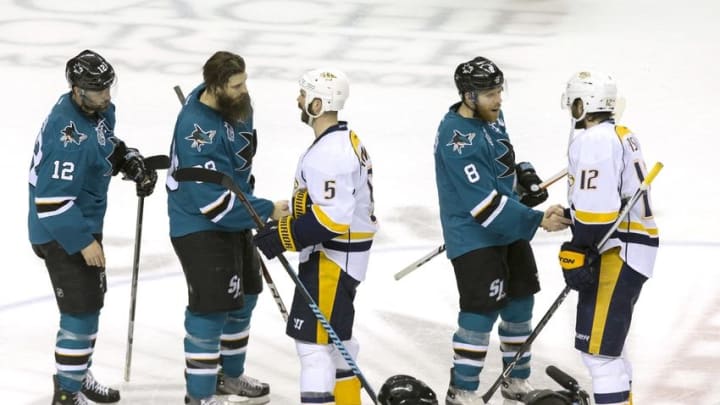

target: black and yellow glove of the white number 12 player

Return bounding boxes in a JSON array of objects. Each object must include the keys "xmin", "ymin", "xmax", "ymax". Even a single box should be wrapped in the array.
[{"xmin": 559, "ymin": 242, "xmax": 600, "ymax": 291}]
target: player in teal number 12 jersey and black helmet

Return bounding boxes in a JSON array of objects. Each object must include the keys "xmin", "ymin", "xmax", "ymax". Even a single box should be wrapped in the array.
[{"xmin": 28, "ymin": 50, "xmax": 157, "ymax": 405}]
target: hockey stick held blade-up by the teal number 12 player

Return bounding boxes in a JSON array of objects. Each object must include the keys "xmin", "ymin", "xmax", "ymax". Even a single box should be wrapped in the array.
[{"xmin": 125, "ymin": 155, "xmax": 170, "ymax": 381}]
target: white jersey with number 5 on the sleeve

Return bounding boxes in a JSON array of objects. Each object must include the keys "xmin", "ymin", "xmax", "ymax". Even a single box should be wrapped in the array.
[{"xmin": 293, "ymin": 122, "xmax": 377, "ymax": 281}]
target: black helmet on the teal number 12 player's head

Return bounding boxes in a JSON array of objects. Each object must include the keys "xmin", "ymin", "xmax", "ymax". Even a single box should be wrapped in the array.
[{"xmin": 65, "ymin": 49, "xmax": 115, "ymax": 91}]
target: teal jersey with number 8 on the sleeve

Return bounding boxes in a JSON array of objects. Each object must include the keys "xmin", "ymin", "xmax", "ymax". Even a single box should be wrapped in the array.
[{"xmin": 434, "ymin": 103, "xmax": 543, "ymax": 259}]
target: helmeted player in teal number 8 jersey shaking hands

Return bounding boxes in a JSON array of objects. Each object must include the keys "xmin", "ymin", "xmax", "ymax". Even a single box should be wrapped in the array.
[{"xmin": 435, "ymin": 57, "xmax": 569, "ymax": 405}]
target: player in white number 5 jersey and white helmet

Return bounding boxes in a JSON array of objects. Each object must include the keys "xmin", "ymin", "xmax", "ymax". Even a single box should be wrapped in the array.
[{"xmin": 255, "ymin": 69, "xmax": 377, "ymax": 405}]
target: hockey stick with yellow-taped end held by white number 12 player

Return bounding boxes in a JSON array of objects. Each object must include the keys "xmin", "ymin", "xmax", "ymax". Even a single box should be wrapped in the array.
[{"xmin": 482, "ymin": 162, "xmax": 663, "ymax": 404}]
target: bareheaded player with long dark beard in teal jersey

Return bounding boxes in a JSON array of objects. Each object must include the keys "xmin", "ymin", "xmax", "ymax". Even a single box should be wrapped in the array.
[{"xmin": 166, "ymin": 51, "xmax": 289, "ymax": 405}]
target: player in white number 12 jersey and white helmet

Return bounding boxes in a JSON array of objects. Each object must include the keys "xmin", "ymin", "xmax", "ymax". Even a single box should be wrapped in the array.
[{"xmin": 560, "ymin": 71, "xmax": 659, "ymax": 405}]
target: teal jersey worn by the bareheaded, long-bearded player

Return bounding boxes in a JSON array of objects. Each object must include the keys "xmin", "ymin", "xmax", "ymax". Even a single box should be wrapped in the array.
[{"xmin": 166, "ymin": 84, "xmax": 274, "ymax": 237}]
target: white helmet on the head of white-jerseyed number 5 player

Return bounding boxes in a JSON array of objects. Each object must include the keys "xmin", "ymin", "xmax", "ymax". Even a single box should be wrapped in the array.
[{"xmin": 300, "ymin": 68, "xmax": 350, "ymax": 117}]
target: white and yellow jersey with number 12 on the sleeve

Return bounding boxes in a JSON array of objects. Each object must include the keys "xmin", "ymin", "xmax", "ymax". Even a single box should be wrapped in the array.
[{"xmin": 568, "ymin": 122, "xmax": 659, "ymax": 277}]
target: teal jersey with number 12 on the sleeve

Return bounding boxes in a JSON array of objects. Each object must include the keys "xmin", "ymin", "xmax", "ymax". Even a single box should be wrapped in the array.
[{"xmin": 28, "ymin": 93, "xmax": 120, "ymax": 254}]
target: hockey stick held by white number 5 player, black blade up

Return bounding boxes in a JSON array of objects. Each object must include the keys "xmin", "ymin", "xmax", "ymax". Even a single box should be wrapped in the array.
[{"xmin": 173, "ymin": 167, "xmax": 377, "ymax": 404}]
